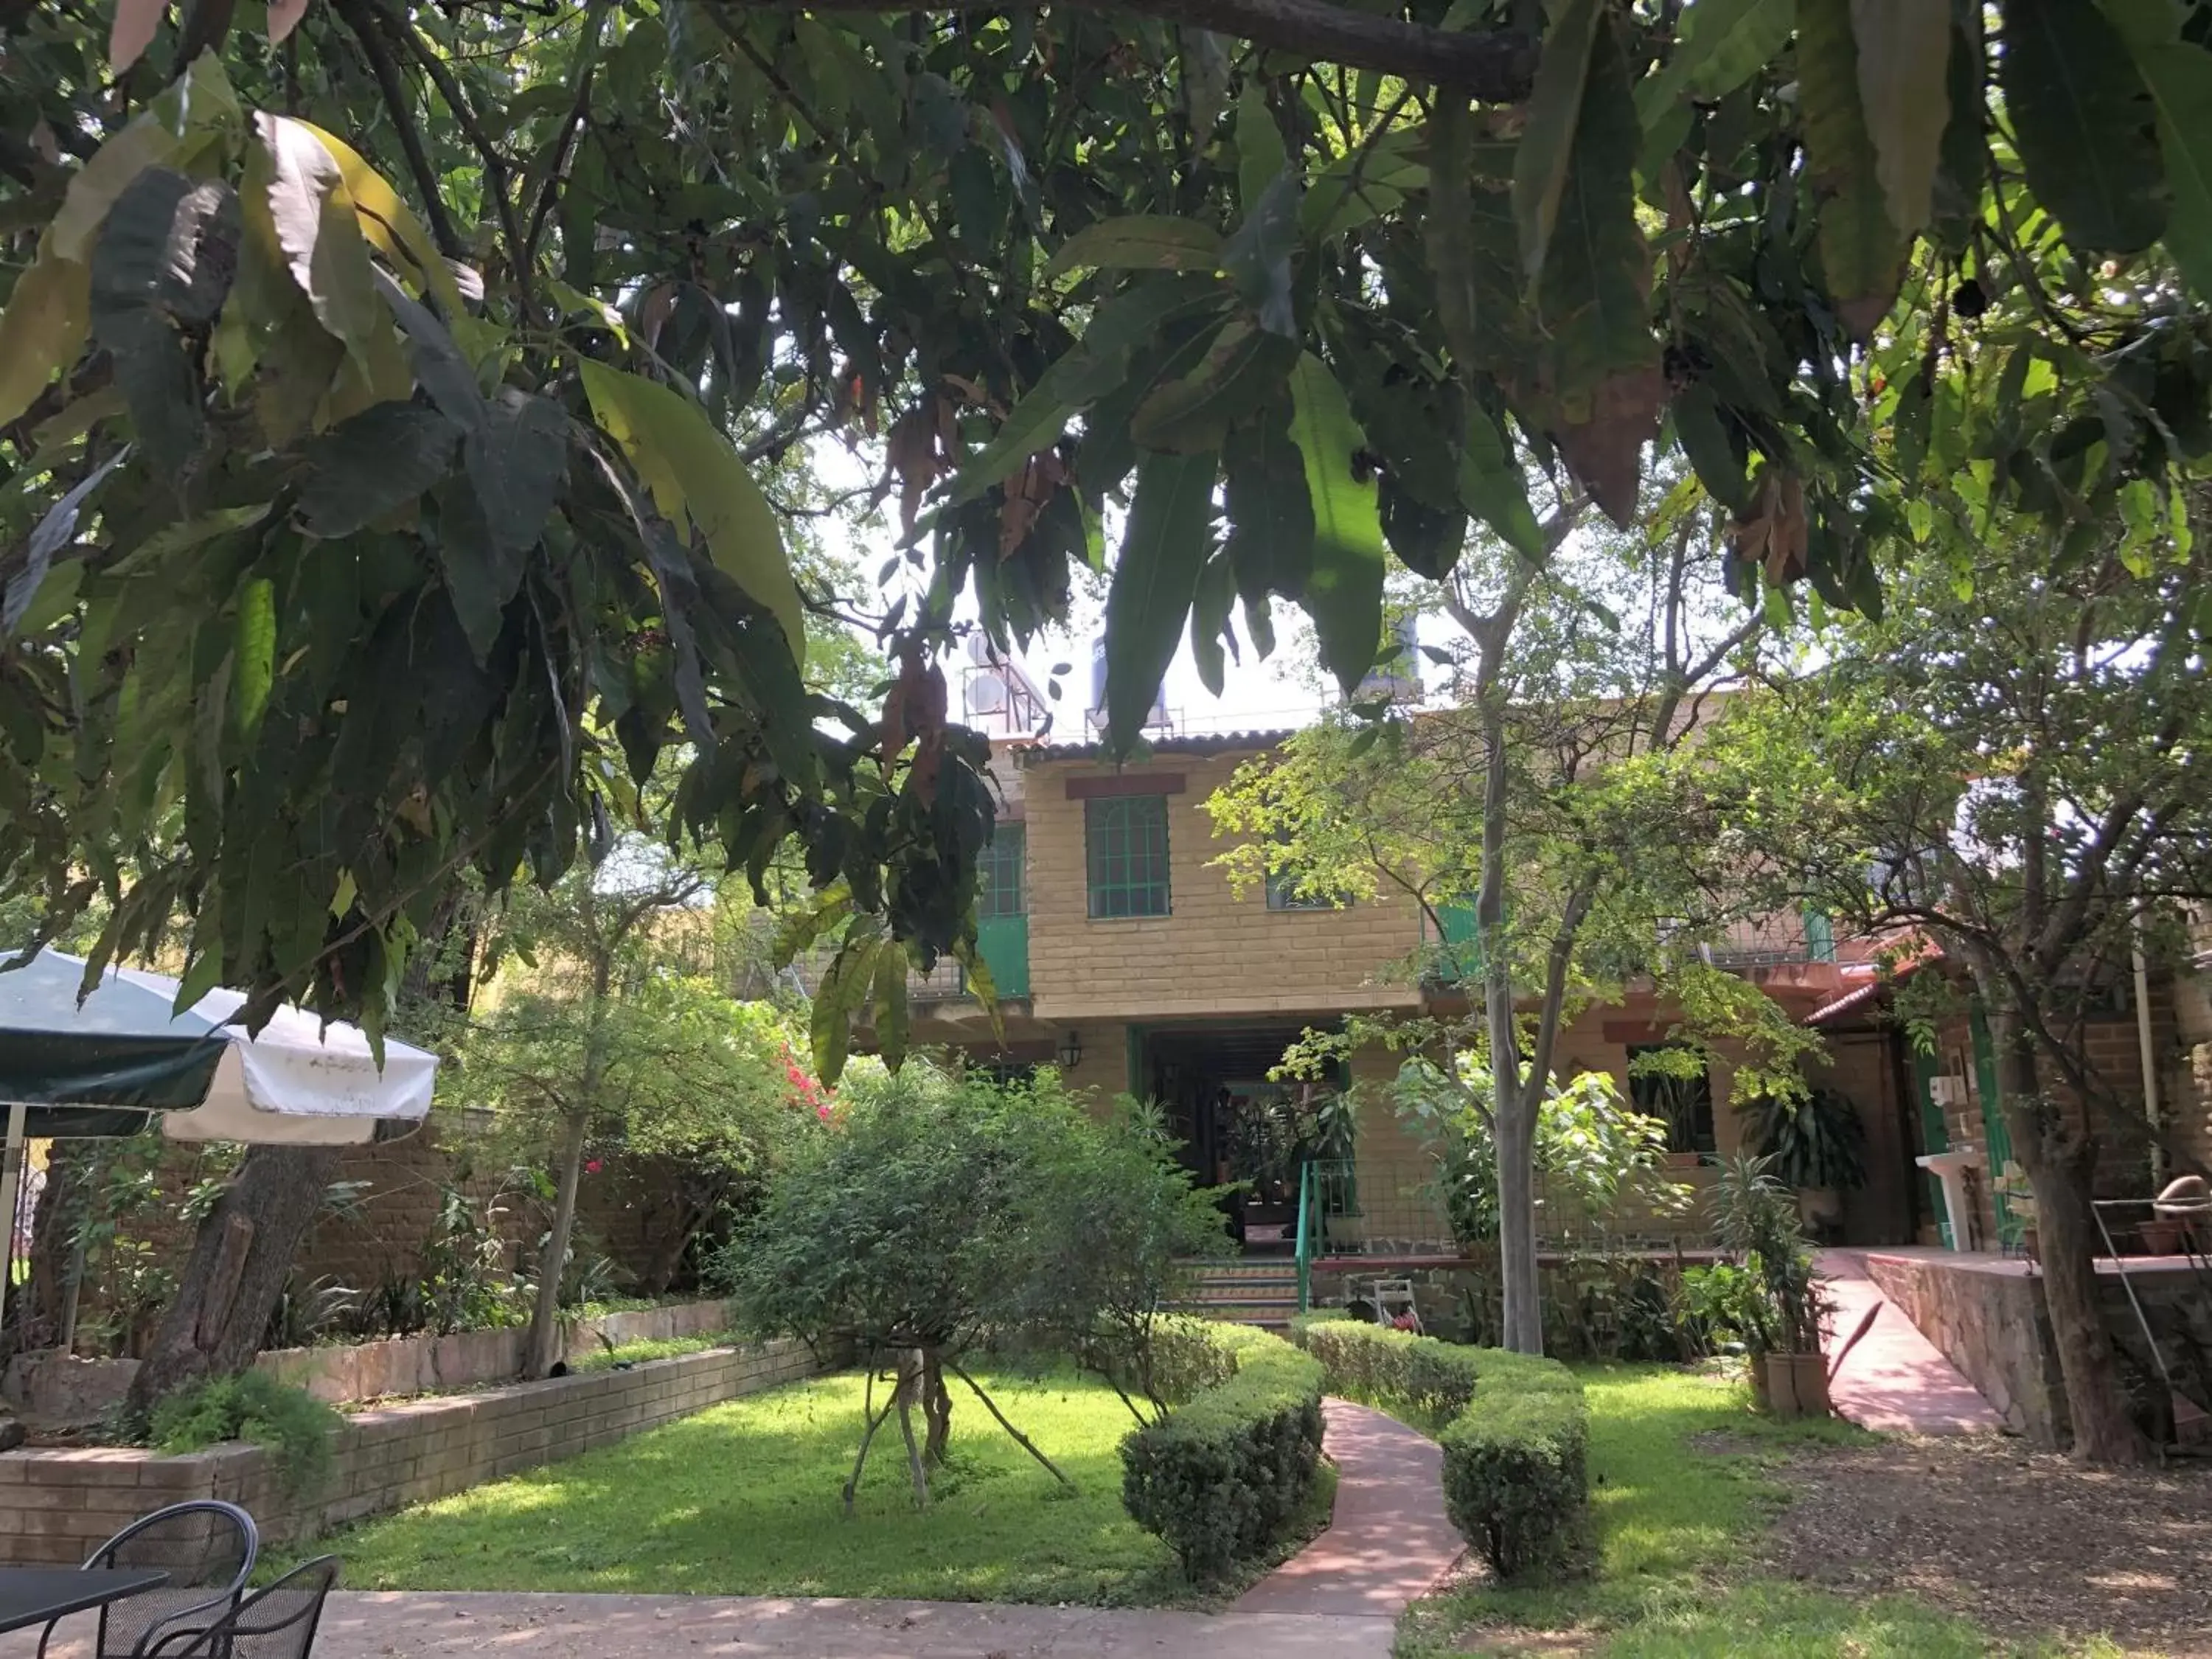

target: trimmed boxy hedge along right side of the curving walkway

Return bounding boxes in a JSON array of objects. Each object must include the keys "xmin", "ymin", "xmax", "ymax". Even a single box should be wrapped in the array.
[{"xmin": 1292, "ymin": 1318, "xmax": 1590, "ymax": 1579}]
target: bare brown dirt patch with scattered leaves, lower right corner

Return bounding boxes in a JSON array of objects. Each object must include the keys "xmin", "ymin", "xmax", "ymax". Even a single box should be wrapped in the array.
[{"xmin": 1767, "ymin": 1436, "xmax": 2212, "ymax": 1659}]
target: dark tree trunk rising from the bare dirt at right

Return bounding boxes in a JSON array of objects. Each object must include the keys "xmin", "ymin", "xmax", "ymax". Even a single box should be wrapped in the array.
[{"xmin": 1991, "ymin": 1009, "xmax": 2150, "ymax": 1464}]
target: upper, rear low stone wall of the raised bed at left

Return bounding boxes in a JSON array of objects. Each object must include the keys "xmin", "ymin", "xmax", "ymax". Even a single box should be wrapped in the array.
[{"xmin": 0, "ymin": 1301, "xmax": 730, "ymax": 1425}]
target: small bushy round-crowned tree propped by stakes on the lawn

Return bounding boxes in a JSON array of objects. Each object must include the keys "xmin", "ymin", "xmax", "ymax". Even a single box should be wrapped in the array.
[{"xmin": 726, "ymin": 1062, "xmax": 1212, "ymax": 1511}]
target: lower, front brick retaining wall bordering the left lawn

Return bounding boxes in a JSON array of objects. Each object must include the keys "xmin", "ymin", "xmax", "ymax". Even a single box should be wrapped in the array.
[{"xmin": 0, "ymin": 1343, "xmax": 823, "ymax": 1566}]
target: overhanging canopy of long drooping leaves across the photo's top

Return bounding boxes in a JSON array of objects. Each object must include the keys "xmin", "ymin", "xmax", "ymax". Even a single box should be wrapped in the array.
[{"xmin": 0, "ymin": 0, "xmax": 2212, "ymax": 1040}]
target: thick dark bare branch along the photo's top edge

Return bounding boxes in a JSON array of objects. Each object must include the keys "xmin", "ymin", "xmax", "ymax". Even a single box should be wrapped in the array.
[{"xmin": 734, "ymin": 0, "xmax": 1540, "ymax": 104}]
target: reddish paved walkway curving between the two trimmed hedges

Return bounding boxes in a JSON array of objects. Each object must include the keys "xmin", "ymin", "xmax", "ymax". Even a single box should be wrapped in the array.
[{"xmin": 1237, "ymin": 1400, "xmax": 1467, "ymax": 1646}]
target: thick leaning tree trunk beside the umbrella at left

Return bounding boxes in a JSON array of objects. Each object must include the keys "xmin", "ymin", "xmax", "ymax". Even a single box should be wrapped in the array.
[{"xmin": 124, "ymin": 1146, "xmax": 338, "ymax": 1420}]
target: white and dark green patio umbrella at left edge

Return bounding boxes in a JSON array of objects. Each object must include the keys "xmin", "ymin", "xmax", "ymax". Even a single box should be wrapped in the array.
[{"xmin": 0, "ymin": 951, "xmax": 438, "ymax": 1345}]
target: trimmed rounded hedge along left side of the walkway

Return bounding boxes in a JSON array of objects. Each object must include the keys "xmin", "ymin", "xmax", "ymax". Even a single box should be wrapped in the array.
[{"xmin": 1121, "ymin": 1325, "xmax": 1321, "ymax": 1579}]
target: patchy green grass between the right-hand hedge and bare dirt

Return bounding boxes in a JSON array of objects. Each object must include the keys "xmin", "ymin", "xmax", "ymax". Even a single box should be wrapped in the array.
[{"xmin": 1398, "ymin": 1365, "xmax": 2099, "ymax": 1659}]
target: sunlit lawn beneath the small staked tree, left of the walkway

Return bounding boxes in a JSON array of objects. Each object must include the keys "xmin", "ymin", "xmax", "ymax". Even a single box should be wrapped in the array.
[{"xmin": 296, "ymin": 1376, "xmax": 1327, "ymax": 1606}]
